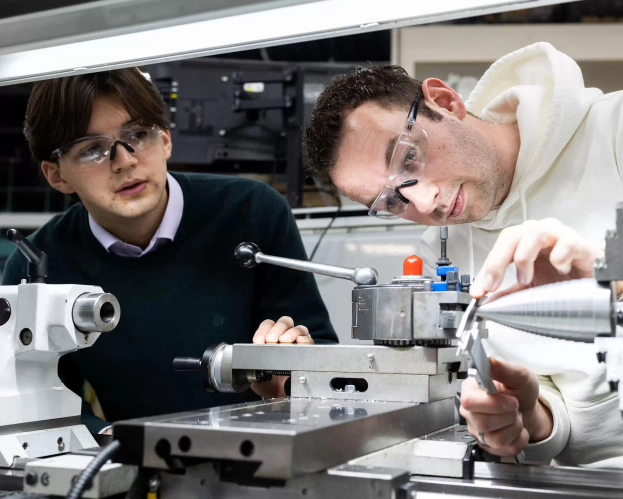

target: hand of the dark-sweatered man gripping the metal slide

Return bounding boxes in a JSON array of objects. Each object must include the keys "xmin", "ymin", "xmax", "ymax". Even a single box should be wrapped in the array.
[{"xmin": 251, "ymin": 316, "xmax": 314, "ymax": 399}]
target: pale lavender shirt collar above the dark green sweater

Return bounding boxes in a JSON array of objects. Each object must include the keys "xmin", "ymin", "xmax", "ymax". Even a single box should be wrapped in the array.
[{"xmin": 89, "ymin": 173, "xmax": 184, "ymax": 258}]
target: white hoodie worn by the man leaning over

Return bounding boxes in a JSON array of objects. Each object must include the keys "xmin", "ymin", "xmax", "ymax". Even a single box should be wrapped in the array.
[{"xmin": 422, "ymin": 43, "xmax": 623, "ymax": 468}]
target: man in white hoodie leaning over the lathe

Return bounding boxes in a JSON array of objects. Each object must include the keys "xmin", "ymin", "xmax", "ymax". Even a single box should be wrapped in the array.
[{"xmin": 305, "ymin": 43, "xmax": 623, "ymax": 466}]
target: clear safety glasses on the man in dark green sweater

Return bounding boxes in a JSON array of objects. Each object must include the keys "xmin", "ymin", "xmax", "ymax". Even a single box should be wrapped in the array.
[{"xmin": 52, "ymin": 122, "xmax": 162, "ymax": 167}]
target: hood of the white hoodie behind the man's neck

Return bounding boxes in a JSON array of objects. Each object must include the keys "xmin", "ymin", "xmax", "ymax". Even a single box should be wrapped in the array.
[{"xmin": 465, "ymin": 42, "xmax": 602, "ymax": 230}]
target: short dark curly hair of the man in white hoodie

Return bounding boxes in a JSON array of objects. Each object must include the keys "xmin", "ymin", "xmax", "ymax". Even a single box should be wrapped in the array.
[{"xmin": 303, "ymin": 65, "xmax": 442, "ymax": 186}]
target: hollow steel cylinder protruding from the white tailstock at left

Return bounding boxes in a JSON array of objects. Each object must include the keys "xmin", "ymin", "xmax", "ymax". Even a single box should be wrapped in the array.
[{"xmin": 71, "ymin": 293, "xmax": 121, "ymax": 333}]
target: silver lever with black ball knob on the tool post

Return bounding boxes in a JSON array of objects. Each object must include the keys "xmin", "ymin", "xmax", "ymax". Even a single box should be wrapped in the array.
[{"xmin": 234, "ymin": 243, "xmax": 378, "ymax": 286}]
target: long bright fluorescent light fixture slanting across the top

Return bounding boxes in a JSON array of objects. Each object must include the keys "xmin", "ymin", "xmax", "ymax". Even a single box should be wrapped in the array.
[{"xmin": 0, "ymin": 0, "xmax": 573, "ymax": 85}]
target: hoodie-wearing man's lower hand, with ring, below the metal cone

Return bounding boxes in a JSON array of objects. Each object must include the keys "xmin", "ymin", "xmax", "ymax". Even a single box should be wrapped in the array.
[{"xmin": 460, "ymin": 359, "xmax": 554, "ymax": 457}]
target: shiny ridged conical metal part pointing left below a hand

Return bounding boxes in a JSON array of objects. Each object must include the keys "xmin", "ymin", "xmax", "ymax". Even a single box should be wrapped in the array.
[{"xmin": 476, "ymin": 279, "xmax": 615, "ymax": 343}]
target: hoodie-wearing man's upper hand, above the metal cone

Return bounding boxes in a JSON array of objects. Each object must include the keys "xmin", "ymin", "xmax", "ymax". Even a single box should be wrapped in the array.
[{"xmin": 470, "ymin": 218, "xmax": 603, "ymax": 298}]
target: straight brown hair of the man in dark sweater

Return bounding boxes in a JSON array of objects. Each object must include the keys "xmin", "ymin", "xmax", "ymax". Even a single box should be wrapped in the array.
[{"xmin": 24, "ymin": 68, "xmax": 170, "ymax": 162}]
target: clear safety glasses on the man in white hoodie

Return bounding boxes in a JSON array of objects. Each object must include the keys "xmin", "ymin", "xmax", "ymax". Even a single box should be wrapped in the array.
[{"xmin": 368, "ymin": 98, "xmax": 428, "ymax": 218}]
